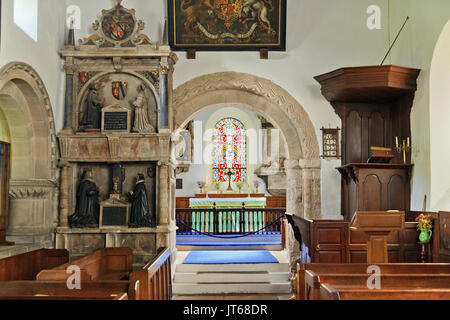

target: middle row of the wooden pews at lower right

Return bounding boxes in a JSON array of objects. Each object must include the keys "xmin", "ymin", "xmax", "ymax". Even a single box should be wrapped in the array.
[{"xmin": 305, "ymin": 270, "xmax": 450, "ymax": 300}]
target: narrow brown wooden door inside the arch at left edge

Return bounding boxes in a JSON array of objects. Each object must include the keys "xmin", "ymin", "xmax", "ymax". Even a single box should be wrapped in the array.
[{"xmin": 0, "ymin": 141, "xmax": 10, "ymax": 245}]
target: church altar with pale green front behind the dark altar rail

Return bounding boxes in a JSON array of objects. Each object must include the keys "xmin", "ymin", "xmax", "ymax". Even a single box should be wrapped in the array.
[{"xmin": 189, "ymin": 197, "xmax": 266, "ymax": 233}]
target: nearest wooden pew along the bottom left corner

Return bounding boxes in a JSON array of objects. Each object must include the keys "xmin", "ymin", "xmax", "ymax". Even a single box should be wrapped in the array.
[{"xmin": 0, "ymin": 281, "xmax": 141, "ymax": 300}]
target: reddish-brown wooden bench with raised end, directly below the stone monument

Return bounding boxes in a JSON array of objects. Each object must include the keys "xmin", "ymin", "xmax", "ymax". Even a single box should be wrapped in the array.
[{"xmin": 36, "ymin": 248, "xmax": 133, "ymax": 281}]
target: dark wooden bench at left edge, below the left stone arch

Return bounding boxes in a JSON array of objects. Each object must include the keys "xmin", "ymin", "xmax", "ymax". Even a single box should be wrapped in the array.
[{"xmin": 0, "ymin": 249, "xmax": 69, "ymax": 281}]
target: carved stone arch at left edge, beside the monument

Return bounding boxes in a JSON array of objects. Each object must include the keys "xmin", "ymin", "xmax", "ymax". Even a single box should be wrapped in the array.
[{"xmin": 0, "ymin": 62, "xmax": 58, "ymax": 247}]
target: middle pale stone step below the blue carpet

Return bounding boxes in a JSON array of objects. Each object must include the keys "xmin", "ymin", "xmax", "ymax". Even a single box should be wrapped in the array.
[{"xmin": 174, "ymin": 272, "xmax": 291, "ymax": 283}]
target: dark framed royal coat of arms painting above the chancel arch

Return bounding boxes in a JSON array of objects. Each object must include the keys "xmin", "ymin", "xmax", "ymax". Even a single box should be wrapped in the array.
[{"xmin": 168, "ymin": 0, "xmax": 286, "ymax": 51}]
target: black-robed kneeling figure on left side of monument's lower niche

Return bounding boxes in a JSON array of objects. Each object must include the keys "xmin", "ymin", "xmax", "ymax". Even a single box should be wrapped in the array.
[{"xmin": 69, "ymin": 169, "xmax": 100, "ymax": 228}]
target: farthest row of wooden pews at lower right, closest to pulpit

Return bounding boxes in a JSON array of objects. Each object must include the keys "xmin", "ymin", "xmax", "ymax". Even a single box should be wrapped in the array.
[{"xmin": 297, "ymin": 263, "xmax": 450, "ymax": 300}]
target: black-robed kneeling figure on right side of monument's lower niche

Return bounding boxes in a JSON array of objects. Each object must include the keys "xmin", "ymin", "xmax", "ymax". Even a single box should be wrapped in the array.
[{"xmin": 129, "ymin": 173, "xmax": 156, "ymax": 228}]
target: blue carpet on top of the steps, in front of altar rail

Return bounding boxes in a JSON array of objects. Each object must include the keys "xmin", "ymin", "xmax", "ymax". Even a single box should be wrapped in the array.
[{"xmin": 183, "ymin": 250, "xmax": 278, "ymax": 264}]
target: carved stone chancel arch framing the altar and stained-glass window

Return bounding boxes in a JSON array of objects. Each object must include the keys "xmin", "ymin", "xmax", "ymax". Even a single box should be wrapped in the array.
[{"xmin": 173, "ymin": 72, "xmax": 321, "ymax": 264}]
